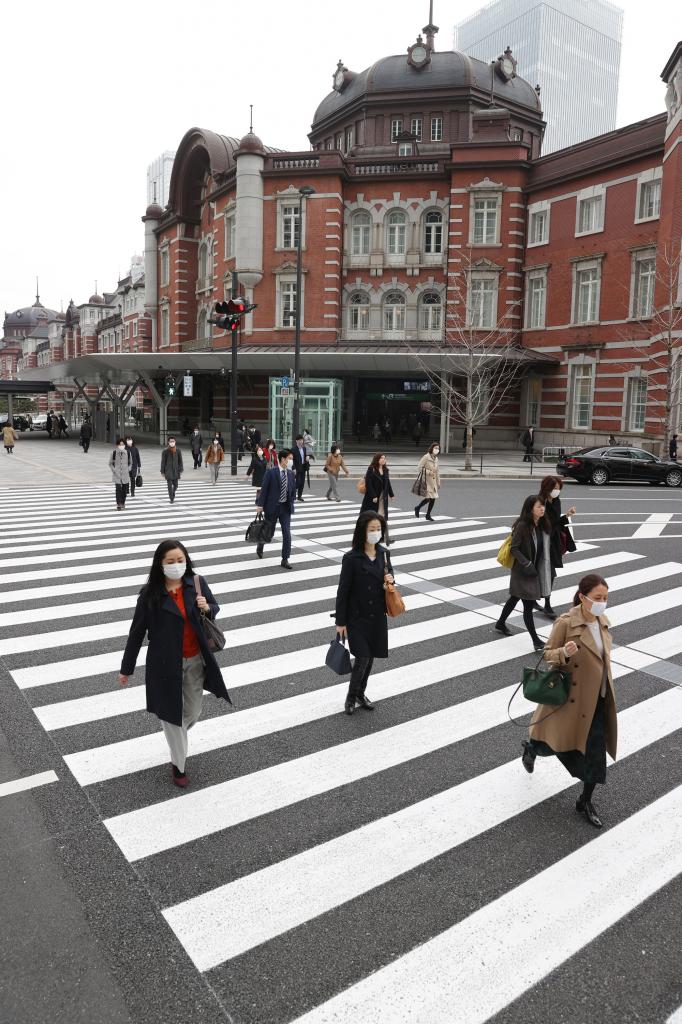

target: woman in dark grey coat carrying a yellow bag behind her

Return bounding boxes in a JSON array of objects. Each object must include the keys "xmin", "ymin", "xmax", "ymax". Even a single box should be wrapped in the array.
[{"xmin": 495, "ymin": 495, "xmax": 552, "ymax": 650}]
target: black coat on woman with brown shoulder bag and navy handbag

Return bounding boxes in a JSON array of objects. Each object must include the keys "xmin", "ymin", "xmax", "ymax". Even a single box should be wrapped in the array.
[{"xmin": 336, "ymin": 544, "xmax": 388, "ymax": 657}]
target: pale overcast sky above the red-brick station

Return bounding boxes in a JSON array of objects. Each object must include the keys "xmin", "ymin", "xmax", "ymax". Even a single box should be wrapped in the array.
[{"xmin": 0, "ymin": 0, "xmax": 682, "ymax": 312}]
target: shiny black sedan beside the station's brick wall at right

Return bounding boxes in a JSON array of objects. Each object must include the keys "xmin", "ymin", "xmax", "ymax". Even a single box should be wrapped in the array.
[{"xmin": 556, "ymin": 447, "xmax": 682, "ymax": 487}]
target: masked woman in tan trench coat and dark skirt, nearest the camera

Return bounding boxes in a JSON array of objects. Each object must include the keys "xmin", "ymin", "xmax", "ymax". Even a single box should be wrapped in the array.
[{"xmin": 521, "ymin": 573, "xmax": 617, "ymax": 828}]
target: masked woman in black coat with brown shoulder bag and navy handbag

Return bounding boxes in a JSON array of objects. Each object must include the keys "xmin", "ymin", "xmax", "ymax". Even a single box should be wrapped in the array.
[{"xmin": 336, "ymin": 512, "xmax": 393, "ymax": 715}]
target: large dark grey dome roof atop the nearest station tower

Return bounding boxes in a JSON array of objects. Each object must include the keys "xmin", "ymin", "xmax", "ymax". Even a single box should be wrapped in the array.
[{"xmin": 312, "ymin": 50, "xmax": 540, "ymax": 129}]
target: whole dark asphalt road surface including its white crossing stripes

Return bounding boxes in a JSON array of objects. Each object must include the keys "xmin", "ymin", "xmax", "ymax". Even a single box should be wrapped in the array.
[{"xmin": 0, "ymin": 449, "xmax": 682, "ymax": 1024}]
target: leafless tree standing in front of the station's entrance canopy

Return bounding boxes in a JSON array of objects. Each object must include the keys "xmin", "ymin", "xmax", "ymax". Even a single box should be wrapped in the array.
[{"xmin": 406, "ymin": 254, "xmax": 531, "ymax": 470}]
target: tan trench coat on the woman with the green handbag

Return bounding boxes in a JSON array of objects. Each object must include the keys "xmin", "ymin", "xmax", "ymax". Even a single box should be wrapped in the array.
[{"xmin": 529, "ymin": 605, "xmax": 617, "ymax": 759}]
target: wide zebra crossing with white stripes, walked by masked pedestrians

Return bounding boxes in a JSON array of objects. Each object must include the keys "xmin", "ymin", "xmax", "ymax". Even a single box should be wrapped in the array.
[{"xmin": 0, "ymin": 476, "xmax": 682, "ymax": 1024}]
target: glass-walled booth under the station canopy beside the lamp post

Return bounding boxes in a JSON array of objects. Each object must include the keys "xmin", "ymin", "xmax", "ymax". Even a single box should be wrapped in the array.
[{"xmin": 270, "ymin": 377, "xmax": 343, "ymax": 453}]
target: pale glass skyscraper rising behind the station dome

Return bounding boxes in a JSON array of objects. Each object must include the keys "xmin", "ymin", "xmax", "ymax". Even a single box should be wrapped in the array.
[{"xmin": 455, "ymin": 0, "xmax": 623, "ymax": 154}]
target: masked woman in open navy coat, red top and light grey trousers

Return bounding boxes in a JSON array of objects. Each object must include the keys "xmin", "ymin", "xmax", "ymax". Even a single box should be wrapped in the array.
[{"xmin": 119, "ymin": 541, "xmax": 231, "ymax": 788}]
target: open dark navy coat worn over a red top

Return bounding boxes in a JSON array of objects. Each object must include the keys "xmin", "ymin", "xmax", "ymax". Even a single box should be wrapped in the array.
[{"xmin": 121, "ymin": 577, "xmax": 231, "ymax": 725}]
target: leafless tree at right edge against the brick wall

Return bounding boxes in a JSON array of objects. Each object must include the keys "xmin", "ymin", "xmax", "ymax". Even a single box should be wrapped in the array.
[{"xmin": 621, "ymin": 246, "xmax": 682, "ymax": 443}]
